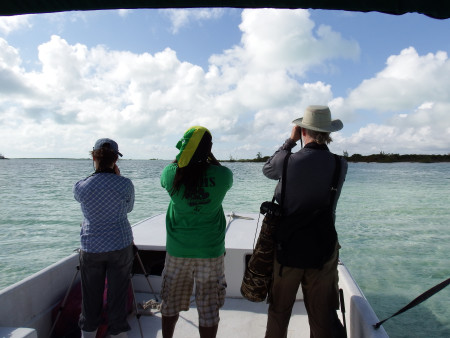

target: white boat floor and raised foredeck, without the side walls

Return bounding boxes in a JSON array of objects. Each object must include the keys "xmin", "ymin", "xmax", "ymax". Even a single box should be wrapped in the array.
[{"xmin": 125, "ymin": 213, "xmax": 322, "ymax": 338}]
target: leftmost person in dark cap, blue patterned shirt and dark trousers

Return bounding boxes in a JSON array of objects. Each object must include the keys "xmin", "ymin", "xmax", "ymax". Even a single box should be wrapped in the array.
[{"xmin": 73, "ymin": 138, "xmax": 134, "ymax": 338}]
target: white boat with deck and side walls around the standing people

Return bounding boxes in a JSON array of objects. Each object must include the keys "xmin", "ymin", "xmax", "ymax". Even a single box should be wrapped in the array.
[{"xmin": 0, "ymin": 213, "xmax": 388, "ymax": 338}]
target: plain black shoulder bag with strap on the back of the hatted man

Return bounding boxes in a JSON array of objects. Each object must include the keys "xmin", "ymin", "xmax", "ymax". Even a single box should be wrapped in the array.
[{"xmin": 275, "ymin": 155, "xmax": 341, "ymax": 269}]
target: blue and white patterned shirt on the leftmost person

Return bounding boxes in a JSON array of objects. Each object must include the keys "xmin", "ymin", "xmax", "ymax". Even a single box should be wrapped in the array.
[{"xmin": 73, "ymin": 173, "xmax": 134, "ymax": 252}]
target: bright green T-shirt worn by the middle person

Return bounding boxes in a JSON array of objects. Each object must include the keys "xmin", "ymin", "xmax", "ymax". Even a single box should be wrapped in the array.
[{"xmin": 161, "ymin": 163, "xmax": 233, "ymax": 258}]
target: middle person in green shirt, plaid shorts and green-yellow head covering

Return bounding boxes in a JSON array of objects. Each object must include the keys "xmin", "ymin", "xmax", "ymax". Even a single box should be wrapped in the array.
[{"xmin": 161, "ymin": 126, "xmax": 233, "ymax": 338}]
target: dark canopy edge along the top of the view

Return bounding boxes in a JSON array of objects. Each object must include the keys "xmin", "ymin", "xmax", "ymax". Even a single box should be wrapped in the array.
[{"xmin": 0, "ymin": 0, "xmax": 450, "ymax": 19}]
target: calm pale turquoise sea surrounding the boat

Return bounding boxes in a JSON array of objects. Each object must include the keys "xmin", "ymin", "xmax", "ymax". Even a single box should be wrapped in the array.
[{"xmin": 0, "ymin": 159, "xmax": 450, "ymax": 338}]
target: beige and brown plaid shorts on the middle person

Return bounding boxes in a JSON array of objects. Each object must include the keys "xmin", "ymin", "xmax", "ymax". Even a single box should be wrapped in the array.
[{"xmin": 161, "ymin": 254, "xmax": 227, "ymax": 327}]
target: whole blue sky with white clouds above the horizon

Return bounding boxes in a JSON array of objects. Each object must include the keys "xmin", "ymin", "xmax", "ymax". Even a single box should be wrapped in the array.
[{"xmin": 0, "ymin": 8, "xmax": 450, "ymax": 160}]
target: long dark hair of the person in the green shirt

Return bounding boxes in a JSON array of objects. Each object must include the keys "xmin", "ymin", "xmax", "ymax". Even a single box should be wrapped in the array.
[{"xmin": 170, "ymin": 133, "xmax": 217, "ymax": 198}]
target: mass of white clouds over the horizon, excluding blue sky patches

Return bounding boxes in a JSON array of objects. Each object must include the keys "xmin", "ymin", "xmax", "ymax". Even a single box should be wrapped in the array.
[{"xmin": 0, "ymin": 9, "xmax": 450, "ymax": 159}]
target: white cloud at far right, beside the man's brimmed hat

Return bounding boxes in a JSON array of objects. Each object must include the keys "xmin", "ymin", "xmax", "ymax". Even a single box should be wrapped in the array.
[{"xmin": 335, "ymin": 47, "xmax": 450, "ymax": 154}]
